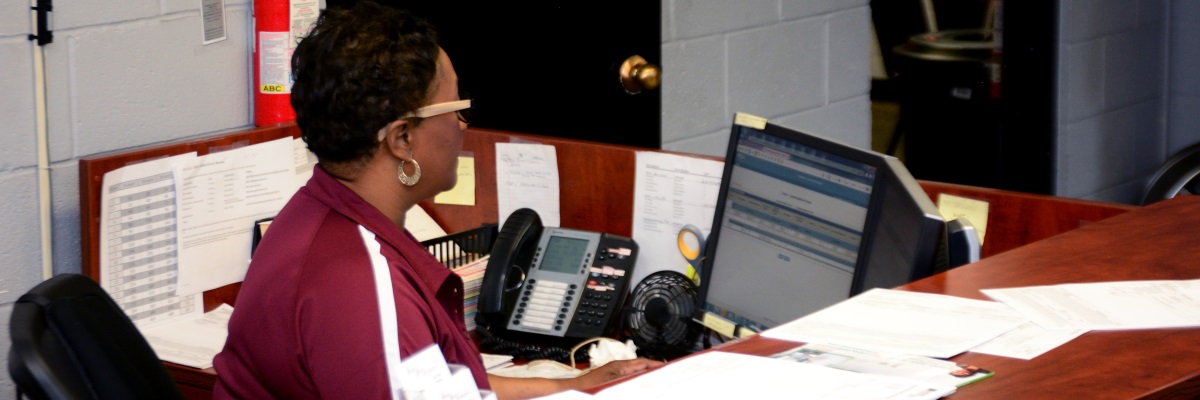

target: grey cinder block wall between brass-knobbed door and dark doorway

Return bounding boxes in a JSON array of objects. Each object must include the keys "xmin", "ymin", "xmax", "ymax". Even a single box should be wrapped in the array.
[{"xmin": 662, "ymin": 0, "xmax": 871, "ymax": 156}]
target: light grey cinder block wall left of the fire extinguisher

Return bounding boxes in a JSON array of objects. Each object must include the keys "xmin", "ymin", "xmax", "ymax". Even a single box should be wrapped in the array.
[{"xmin": 0, "ymin": 0, "xmax": 251, "ymax": 391}]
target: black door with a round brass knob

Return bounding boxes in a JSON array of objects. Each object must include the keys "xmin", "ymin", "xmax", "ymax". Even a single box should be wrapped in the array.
[{"xmin": 328, "ymin": 0, "xmax": 662, "ymax": 149}]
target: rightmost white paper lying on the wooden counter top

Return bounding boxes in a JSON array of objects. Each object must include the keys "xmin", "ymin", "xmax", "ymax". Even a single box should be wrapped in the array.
[{"xmin": 982, "ymin": 280, "xmax": 1200, "ymax": 330}]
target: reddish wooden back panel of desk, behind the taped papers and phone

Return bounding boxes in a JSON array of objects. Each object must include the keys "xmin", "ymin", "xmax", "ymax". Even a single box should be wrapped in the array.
[{"xmin": 79, "ymin": 124, "xmax": 1133, "ymax": 399}]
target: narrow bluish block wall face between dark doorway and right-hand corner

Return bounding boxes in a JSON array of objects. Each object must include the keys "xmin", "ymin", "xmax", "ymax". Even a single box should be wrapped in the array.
[{"xmin": 1055, "ymin": 0, "xmax": 1168, "ymax": 202}]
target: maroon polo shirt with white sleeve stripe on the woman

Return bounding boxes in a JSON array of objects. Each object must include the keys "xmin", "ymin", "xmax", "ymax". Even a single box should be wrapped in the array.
[{"xmin": 214, "ymin": 167, "xmax": 488, "ymax": 399}]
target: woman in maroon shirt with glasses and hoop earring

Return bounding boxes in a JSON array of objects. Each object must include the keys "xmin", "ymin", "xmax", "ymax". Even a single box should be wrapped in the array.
[{"xmin": 214, "ymin": 2, "xmax": 659, "ymax": 399}]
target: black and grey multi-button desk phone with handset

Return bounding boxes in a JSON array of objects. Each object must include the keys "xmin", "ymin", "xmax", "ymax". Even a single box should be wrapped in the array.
[{"xmin": 476, "ymin": 208, "xmax": 637, "ymax": 342}]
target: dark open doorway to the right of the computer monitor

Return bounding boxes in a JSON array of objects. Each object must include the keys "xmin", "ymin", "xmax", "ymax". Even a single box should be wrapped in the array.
[{"xmin": 870, "ymin": 0, "xmax": 1058, "ymax": 195}]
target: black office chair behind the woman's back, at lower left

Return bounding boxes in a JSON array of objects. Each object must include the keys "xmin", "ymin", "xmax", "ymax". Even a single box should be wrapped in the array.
[{"xmin": 8, "ymin": 274, "xmax": 182, "ymax": 399}]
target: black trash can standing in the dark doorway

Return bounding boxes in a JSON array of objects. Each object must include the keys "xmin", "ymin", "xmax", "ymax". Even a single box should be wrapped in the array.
[{"xmin": 893, "ymin": 30, "xmax": 1001, "ymax": 187}]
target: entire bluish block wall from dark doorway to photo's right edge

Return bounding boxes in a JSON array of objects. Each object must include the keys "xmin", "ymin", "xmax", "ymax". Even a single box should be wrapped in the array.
[{"xmin": 1055, "ymin": 0, "xmax": 1200, "ymax": 203}]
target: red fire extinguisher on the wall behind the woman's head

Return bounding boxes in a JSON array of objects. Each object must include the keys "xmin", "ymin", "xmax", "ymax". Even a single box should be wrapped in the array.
[{"xmin": 253, "ymin": 0, "xmax": 320, "ymax": 126}]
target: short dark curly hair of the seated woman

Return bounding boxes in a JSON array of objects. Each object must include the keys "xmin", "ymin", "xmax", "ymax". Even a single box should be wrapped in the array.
[{"xmin": 292, "ymin": 1, "xmax": 440, "ymax": 162}]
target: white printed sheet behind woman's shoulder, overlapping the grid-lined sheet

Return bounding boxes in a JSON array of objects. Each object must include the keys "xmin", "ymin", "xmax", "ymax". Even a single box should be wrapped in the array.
[{"xmin": 176, "ymin": 137, "xmax": 299, "ymax": 294}]
